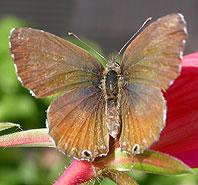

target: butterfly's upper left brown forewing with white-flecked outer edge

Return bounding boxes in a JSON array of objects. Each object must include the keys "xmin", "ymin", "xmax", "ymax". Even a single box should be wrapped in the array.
[{"xmin": 10, "ymin": 28, "xmax": 103, "ymax": 97}]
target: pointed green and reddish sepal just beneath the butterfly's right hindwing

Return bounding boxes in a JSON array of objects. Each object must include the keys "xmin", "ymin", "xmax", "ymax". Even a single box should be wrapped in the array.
[{"xmin": 94, "ymin": 148, "xmax": 193, "ymax": 175}]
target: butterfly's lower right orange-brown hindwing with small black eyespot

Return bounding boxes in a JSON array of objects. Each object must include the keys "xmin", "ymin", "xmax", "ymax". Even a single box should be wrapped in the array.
[{"xmin": 119, "ymin": 83, "xmax": 166, "ymax": 154}]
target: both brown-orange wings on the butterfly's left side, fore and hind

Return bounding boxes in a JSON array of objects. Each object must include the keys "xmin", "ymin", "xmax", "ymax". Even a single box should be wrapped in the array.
[{"xmin": 10, "ymin": 28, "xmax": 109, "ymax": 160}]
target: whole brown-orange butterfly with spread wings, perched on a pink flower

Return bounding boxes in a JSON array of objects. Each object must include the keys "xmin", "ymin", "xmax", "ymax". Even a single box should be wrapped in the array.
[{"xmin": 10, "ymin": 14, "xmax": 187, "ymax": 161}]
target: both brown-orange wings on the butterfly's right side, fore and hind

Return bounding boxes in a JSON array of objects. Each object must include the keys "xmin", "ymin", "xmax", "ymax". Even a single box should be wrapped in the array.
[{"xmin": 120, "ymin": 14, "xmax": 187, "ymax": 154}]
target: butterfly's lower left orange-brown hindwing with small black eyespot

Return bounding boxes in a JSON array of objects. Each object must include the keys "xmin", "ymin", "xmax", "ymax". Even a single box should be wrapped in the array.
[{"xmin": 48, "ymin": 86, "xmax": 109, "ymax": 161}]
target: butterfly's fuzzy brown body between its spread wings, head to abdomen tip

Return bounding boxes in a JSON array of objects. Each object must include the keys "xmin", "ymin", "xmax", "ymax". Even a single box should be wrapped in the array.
[{"xmin": 102, "ymin": 60, "xmax": 123, "ymax": 138}]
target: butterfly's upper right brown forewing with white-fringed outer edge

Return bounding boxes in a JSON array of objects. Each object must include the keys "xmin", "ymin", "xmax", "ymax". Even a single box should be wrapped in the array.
[{"xmin": 121, "ymin": 14, "xmax": 187, "ymax": 90}]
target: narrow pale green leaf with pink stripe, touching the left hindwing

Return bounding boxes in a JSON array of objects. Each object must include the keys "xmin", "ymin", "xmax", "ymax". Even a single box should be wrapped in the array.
[{"xmin": 0, "ymin": 129, "xmax": 55, "ymax": 147}]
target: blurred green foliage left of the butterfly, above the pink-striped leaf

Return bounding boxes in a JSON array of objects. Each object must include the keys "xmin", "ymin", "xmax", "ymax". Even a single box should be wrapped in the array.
[{"xmin": 0, "ymin": 17, "xmax": 49, "ymax": 129}]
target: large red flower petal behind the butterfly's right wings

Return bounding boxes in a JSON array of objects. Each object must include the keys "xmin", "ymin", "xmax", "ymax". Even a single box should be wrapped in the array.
[{"xmin": 151, "ymin": 53, "xmax": 198, "ymax": 167}]
